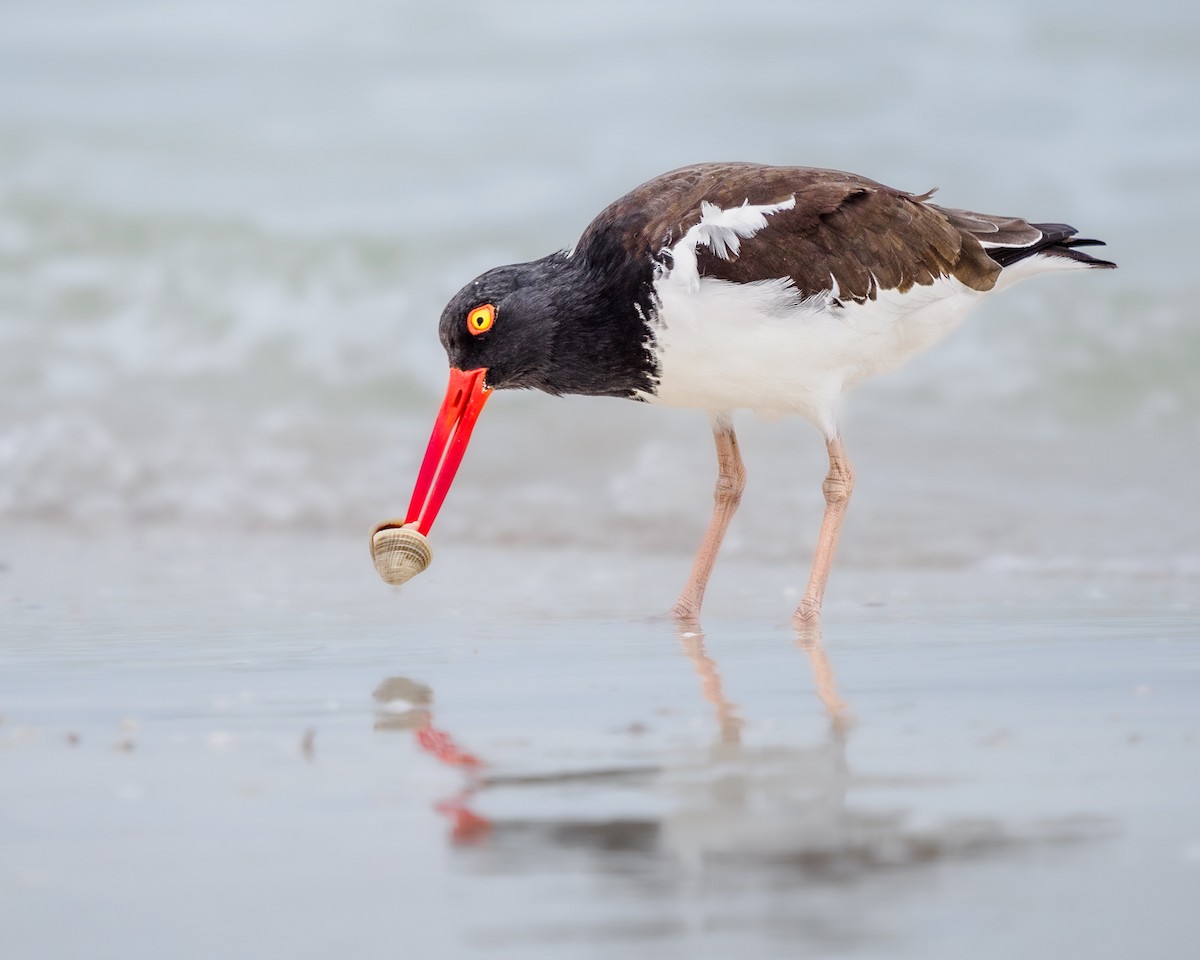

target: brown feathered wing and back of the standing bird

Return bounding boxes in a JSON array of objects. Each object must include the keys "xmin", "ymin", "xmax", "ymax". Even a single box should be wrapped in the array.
[{"xmin": 576, "ymin": 163, "xmax": 1008, "ymax": 301}]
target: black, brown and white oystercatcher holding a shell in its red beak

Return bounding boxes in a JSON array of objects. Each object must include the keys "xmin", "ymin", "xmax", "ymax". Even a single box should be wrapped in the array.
[{"xmin": 381, "ymin": 163, "xmax": 1115, "ymax": 622}]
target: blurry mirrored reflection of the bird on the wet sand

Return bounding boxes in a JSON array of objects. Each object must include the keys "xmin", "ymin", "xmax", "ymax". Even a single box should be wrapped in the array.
[{"xmin": 376, "ymin": 623, "xmax": 1100, "ymax": 953}]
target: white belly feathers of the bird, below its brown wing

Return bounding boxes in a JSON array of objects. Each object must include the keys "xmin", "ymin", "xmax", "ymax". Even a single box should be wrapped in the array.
[{"xmin": 646, "ymin": 277, "xmax": 979, "ymax": 436}]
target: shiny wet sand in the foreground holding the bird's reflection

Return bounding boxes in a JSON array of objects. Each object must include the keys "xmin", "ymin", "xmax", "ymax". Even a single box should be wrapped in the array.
[{"xmin": 0, "ymin": 526, "xmax": 1200, "ymax": 958}]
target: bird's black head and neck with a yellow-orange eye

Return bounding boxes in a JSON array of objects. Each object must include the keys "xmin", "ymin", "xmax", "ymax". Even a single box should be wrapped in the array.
[{"xmin": 439, "ymin": 253, "xmax": 656, "ymax": 397}]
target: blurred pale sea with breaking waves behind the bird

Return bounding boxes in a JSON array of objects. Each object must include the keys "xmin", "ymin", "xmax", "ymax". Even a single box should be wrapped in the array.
[{"xmin": 0, "ymin": 0, "xmax": 1200, "ymax": 586}]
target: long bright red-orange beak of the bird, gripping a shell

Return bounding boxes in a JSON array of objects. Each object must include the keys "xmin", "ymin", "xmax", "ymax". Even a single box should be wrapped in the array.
[{"xmin": 404, "ymin": 367, "xmax": 492, "ymax": 535}]
